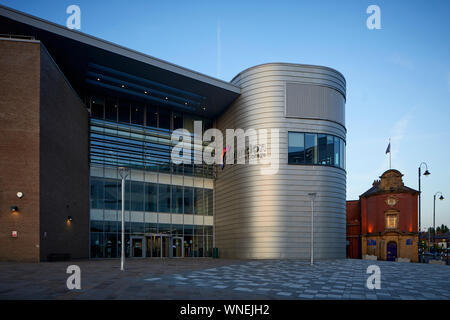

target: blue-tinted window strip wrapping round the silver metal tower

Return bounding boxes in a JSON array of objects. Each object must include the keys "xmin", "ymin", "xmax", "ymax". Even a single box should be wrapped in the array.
[{"xmin": 288, "ymin": 132, "xmax": 345, "ymax": 169}]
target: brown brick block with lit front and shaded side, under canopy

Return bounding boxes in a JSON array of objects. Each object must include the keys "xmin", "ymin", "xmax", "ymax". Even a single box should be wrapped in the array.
[{"xmin": 0, "ymin": 39, "xmax": 89, "ymax": 262}]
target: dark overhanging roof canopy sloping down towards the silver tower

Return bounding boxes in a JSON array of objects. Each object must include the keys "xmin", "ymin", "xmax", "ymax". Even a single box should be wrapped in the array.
[{"xmin": 0, "ymin": 6, "xmax": 240, "ymax": 118}]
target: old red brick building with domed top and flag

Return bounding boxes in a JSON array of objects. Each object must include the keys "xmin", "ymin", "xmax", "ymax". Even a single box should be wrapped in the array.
[{"xmin": 347, "ymin": 169, "xmax": 419, "ymax": 262}]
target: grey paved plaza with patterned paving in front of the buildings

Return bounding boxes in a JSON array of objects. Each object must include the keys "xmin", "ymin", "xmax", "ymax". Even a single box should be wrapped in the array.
[{"xmin": 0, "ymin": 258, "xmax": 450, "ymax": 300}]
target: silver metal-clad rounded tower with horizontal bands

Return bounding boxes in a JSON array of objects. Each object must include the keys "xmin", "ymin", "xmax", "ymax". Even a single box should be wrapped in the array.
[{"xmin": 215, "ymin": 63, "xmax": 346, "ymax": 259}]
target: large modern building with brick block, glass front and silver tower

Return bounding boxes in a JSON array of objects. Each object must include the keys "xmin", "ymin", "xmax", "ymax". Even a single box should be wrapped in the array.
[{"xmin": 0, "ymin": 6, "xmax": 346, "ymax": 261}]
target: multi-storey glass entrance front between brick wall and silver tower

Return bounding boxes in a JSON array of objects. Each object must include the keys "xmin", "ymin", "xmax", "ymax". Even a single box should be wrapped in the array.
[{"xmin": 86, "ymin": 94, "xmax": 214, "ymax": 258}]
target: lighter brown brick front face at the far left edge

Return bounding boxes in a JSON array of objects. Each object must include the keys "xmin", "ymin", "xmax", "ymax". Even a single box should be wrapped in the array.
[{"xmin": 0, "ymin": 40, "xmax": 40, "ymax": 262}]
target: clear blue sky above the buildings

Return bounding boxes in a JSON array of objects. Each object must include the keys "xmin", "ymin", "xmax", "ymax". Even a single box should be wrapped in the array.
[{"xmin": 0, "ymin": 0, "xmax": 450, "ymax": 226}]
